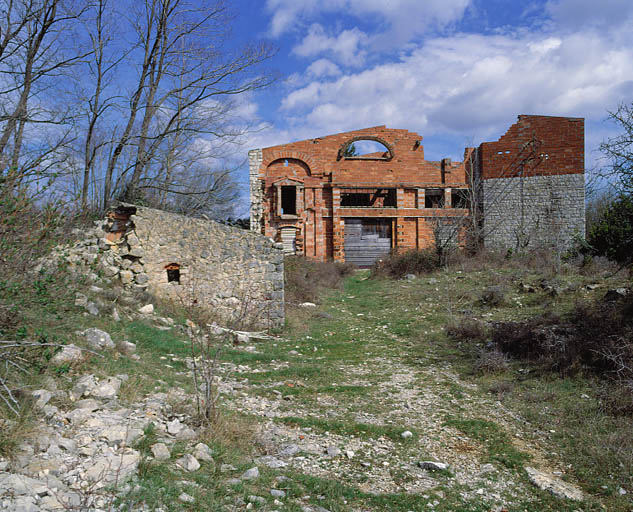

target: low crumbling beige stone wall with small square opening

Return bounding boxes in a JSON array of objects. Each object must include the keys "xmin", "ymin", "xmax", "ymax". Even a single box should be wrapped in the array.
[{"xmin": 100, "ymin": 205, "xmax": 284, "ymax": 327}]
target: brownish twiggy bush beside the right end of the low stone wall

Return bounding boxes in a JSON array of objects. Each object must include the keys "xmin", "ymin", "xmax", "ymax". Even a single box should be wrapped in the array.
[{"xmin": 284, "ymin": 256, "xmax": 356, "ymax": 304}]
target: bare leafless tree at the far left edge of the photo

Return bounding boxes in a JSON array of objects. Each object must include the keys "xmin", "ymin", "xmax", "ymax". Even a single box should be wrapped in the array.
[{"xmin": 0, "ymin": 0, "xmax": 87, "ymax": 186}]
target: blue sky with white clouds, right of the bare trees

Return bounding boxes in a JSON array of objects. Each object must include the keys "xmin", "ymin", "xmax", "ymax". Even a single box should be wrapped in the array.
[{"xmin": 222, "ymin": 0, "xmax": 633, "ymax": 209}]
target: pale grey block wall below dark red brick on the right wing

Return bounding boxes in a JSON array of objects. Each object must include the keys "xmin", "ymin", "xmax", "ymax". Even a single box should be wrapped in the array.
[{"xmin": 483, "ymin": 174, "xmax": 585, "ymax": 249}]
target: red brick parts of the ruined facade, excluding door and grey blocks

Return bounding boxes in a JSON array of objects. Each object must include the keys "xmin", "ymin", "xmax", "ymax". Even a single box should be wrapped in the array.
[{"xmin": 251, "ymin": 116, "xmax": 584, "ymax": 261}]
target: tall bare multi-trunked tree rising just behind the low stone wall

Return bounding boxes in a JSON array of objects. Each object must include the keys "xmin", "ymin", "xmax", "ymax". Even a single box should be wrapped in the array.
[{"xmin": 103, "ymin": 0, "xmax": 272, "ymax": 210}]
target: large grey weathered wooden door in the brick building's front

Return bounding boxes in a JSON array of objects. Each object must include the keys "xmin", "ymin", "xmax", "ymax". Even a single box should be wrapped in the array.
[{"xmin": 345, "ymin": 219, "xmax": 391, "ymax": 267}]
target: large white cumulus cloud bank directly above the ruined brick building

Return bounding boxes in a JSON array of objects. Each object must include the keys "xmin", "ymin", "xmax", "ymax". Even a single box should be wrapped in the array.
[{"xmin": 282, "ymin": 24, "xmax": 633, "ymax": 144}]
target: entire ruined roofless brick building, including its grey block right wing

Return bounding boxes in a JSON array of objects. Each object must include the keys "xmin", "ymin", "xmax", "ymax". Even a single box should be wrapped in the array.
[{"xmin": 249, "ymin": 115, "xmax": 585, "ymax": 266}]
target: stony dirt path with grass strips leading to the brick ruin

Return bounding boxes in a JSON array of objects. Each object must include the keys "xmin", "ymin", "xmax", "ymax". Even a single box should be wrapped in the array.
[{"xmin": 217, "ymin": 274, "xmax": 593, "ymax": 511}]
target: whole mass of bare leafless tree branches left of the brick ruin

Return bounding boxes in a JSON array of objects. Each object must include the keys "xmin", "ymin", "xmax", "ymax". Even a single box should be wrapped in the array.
[{"xmin": 0, "ymin": 0, "xmax": 273, "ymax": 215}]
